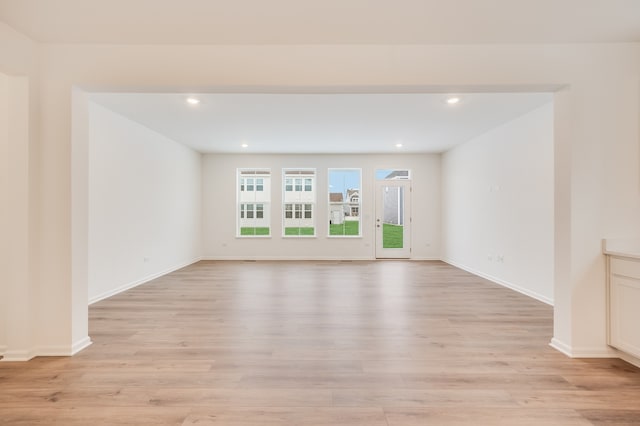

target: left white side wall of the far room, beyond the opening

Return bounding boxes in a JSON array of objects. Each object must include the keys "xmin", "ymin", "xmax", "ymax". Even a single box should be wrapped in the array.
[{"xmin": 88, "ymin": 103, "xmax": 202, "ymax": 301}]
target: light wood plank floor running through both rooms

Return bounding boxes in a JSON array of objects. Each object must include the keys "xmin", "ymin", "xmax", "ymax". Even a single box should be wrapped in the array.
[{"xmin": 0, "ymin": 261, "xmax": 640, "ymax": 426}]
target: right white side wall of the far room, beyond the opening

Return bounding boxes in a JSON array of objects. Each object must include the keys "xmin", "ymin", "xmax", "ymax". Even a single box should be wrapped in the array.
[{"xmin": 442, "ymin": 104, "xmax": 554, "ymax": 304}]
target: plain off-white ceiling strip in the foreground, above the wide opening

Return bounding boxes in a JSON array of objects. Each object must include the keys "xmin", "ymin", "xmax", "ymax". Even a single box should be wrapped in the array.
[{"xmin": 0, "ymin": 0, "xmax": 640, "ymax": 44}]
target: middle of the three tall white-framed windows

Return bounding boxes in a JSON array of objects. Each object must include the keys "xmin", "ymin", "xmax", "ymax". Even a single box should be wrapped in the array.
[{"xmin": 282, "ymin": 169, "xmax": 316, "ymax": 237}]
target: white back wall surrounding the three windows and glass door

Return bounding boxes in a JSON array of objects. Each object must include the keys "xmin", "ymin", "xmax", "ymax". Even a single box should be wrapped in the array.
[{"xmin": 202, "ymin": 154, "xmax": 440, "ymax": 259}]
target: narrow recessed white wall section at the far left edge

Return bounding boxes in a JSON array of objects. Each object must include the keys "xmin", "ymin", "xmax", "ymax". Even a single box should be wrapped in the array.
[{"xmin": 0, "ymin": 70, "xmax": 34, "ymax": 361}]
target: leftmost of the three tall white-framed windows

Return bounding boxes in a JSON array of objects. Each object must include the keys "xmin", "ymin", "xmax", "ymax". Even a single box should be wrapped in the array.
[{"xmin": 236, "ymin": 169, "xmax": 271, "ymax": 237}]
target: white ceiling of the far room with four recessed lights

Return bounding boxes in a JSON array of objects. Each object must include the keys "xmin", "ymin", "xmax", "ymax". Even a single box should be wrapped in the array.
[{"xmin": 91, "ymin": 93, "xmax": 552, "ymax": 153}]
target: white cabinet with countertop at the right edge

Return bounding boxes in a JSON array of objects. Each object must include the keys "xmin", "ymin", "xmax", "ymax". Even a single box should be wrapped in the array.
[{"xmin": 608, "ymin": 256, "xmax": 640, "ymax": 358}]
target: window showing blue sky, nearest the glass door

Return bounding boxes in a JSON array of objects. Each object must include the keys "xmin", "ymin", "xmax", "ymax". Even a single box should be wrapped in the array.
[{"xmin": 328, "ymin": 169, "xmax": 362, "ymax": 237}]
